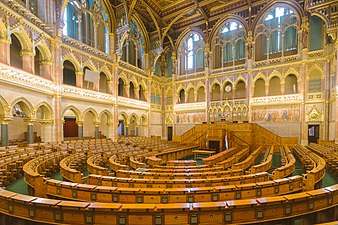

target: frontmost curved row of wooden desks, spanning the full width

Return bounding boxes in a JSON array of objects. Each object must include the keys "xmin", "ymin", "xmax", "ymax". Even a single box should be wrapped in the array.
[{"xmin": 0, "ymin": 185, "xmax": 338, "ymax": 225}]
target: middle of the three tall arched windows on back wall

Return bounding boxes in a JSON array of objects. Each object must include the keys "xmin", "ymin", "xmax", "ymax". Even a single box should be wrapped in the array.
[{"xmin": 213, "ymin": 21, "xmax": 246, "ymax": 68}]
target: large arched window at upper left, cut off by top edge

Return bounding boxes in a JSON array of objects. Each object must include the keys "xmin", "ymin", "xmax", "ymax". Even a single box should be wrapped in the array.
[{"xmin": 63, "ymin": 0, "xmax": 109, "ymax": 53}]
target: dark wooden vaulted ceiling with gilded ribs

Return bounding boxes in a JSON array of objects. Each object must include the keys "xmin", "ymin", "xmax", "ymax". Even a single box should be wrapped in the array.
[{"xmin": 111, "ymin": 0, "xmax": 304, "ymax": 45}]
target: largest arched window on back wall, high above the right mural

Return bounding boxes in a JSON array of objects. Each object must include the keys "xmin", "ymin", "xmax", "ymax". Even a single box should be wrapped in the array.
[{"xmin": 255, "ymin": 7, "xmax": 298, "ymax": 60}]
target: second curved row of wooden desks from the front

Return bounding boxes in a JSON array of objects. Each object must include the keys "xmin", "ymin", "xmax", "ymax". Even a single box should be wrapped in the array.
[{"xmin": 44, "ymin": 176, "xmax": 303, "ymax": 204}]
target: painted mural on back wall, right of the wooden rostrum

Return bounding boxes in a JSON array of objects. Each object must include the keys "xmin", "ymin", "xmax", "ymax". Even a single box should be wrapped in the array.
[{"xmin": 252, "ymin": 105, "xmax": 300, "ymax": 123}]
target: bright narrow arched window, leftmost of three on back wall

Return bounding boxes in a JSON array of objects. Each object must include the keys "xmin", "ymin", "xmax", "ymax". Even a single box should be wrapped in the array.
[{"xmin": 179, "ymin": 33, "xmax": 204, "ymax": 74}]
